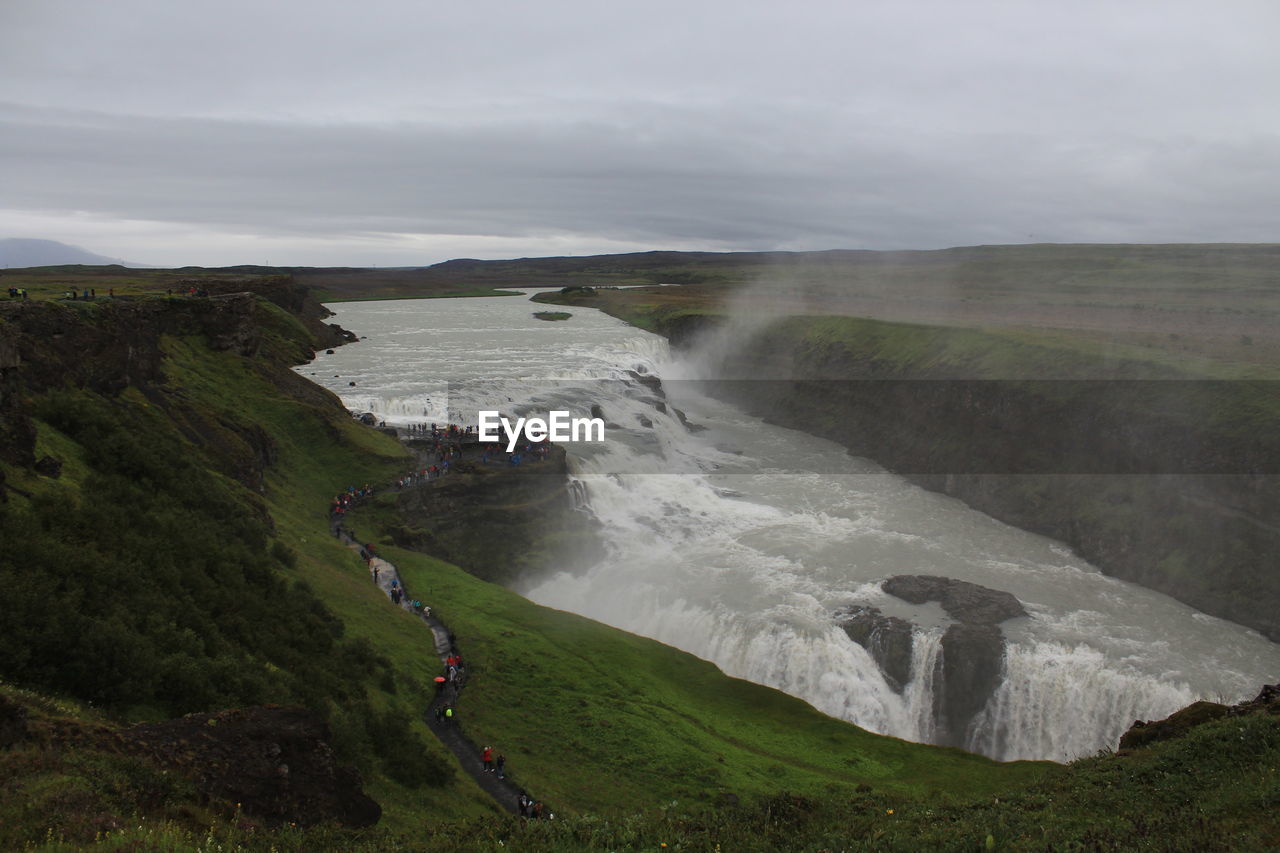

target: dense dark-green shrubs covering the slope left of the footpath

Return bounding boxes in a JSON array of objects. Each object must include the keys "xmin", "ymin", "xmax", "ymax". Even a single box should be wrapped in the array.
[{"xmin": 8, "ymin": 391, "xmax": 371, "ymax": 715}]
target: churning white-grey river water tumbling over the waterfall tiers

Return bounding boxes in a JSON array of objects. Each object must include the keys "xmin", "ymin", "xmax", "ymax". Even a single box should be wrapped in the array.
[{"xmin": 298, "ymin": 297, "xmax": 1280, "ymax": 761}]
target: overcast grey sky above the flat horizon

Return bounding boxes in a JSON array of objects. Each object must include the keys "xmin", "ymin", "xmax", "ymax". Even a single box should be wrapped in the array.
[{"xmin": 0, "ymin": 0, "xmax": 1280, "ymax": 265}]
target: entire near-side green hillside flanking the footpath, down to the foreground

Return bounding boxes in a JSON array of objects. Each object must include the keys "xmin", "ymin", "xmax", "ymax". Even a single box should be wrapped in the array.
[{"xmin": 0, "ymin": 286, "xmax": 1280, "ymax": 852}]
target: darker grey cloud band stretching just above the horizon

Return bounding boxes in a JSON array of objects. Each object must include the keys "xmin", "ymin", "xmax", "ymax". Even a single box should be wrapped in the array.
[{"xmin": 10, "ymin": 96, "xmax": 1280, "ymax": 256}]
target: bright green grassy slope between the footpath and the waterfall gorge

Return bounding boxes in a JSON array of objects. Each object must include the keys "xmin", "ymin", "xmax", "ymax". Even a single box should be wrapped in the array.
[{"xmin": 381, "ymin": 547, "xmax": 1052, "ymax": 812}]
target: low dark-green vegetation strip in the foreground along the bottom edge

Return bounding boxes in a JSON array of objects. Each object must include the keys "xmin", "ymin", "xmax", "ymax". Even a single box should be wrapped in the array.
[{"xmin": 12, "ymin": 686, "xmax": 1280, "ymax": 853}]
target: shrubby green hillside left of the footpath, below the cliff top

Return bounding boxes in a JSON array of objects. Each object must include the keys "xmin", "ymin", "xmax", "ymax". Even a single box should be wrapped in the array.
[{"xmin": 0, "ymin": 294, "xmax": 492, "ymax": 848}]
